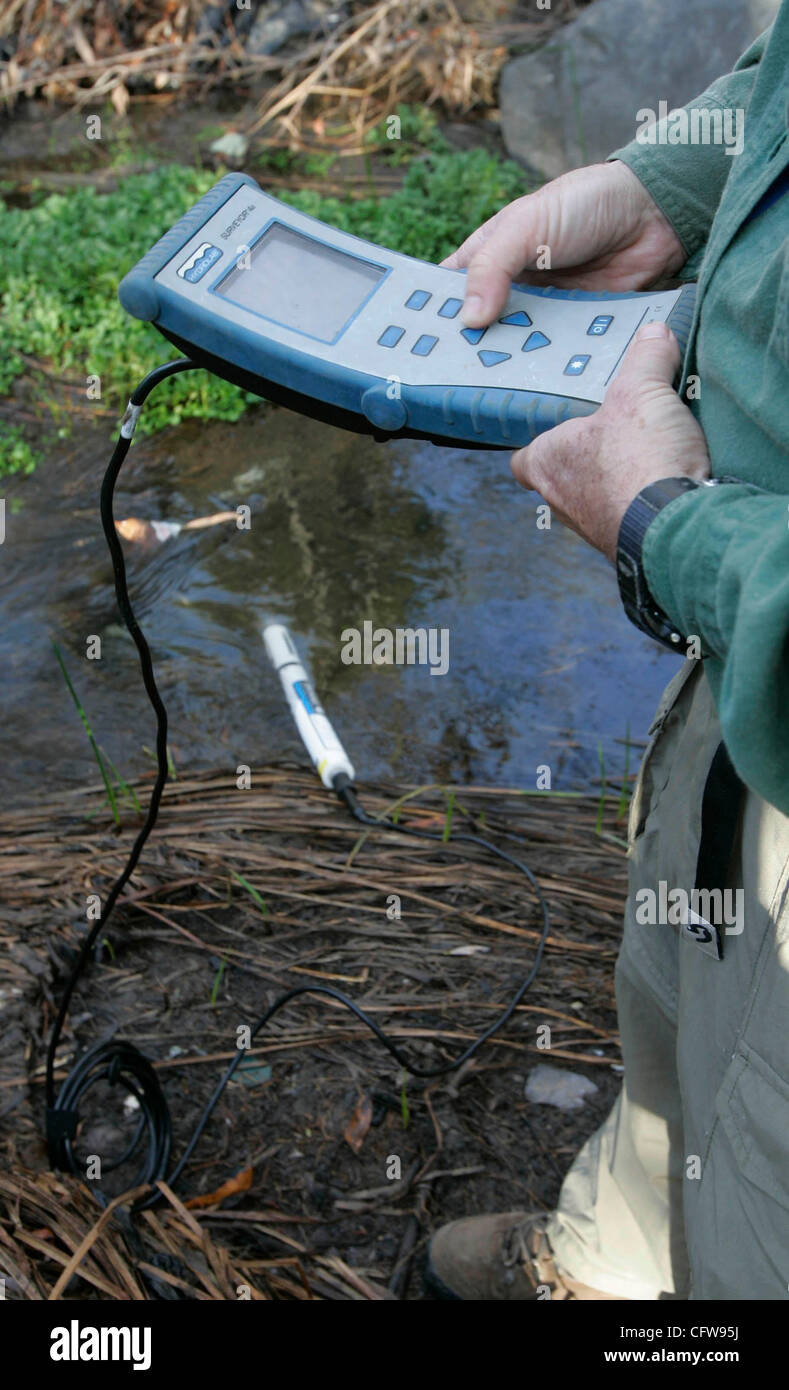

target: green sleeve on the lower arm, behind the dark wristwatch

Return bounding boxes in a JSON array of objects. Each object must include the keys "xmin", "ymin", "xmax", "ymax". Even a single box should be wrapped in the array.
[{"xmin": 643, "ymin": 482, "xmax": 789, "ymax": 815}]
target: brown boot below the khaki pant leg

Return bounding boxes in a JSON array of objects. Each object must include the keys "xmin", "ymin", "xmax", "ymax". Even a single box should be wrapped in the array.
[{"xmin": 425, "ymin": 1212, "xmax": 624, "ymax": 1302}]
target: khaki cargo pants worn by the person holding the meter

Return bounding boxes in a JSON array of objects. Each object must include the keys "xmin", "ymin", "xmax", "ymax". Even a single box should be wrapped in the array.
[{"xmin": 549, "ymin": 662, "xmax": 789, "ymax": 1300}]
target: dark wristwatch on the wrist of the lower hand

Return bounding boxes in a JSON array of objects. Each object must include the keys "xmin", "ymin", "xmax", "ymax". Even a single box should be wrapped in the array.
[{"xmin": 617, "ymin": 477, "xmax": 742, "ymax": 655}]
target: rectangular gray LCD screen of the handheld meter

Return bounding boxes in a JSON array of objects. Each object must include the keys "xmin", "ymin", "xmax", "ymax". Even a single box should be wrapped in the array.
[{"xmin": 217, "ymin": 222, "xmax": 386, "ymax": 343}]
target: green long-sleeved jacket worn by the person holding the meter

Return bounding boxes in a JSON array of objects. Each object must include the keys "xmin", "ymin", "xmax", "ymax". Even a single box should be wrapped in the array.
[{"xmin": 610, "ymin": 8, "xmax": 789, "ymax": 815}]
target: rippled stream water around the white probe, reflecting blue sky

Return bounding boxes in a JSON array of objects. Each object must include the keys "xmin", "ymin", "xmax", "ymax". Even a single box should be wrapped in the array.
[{"xmin": 0, "ymin": 407, "xmax": 676, "ymax": 801}]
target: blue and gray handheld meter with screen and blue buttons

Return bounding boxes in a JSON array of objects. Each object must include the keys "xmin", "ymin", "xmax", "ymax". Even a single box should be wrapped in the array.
[{"xmin": 118, "ymin": 174, "xmax": 695, "ymax": 449}]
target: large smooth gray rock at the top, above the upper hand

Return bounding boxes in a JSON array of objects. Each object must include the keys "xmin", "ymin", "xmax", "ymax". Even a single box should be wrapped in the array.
[{"xmin": 499, "ymin": 0, "xmax": 779, "ymax": 178}]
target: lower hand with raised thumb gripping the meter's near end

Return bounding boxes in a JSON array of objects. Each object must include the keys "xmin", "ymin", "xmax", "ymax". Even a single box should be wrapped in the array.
[{"xmin": 511, "ymin": 324, "xmax": 710, "ymax": 560}]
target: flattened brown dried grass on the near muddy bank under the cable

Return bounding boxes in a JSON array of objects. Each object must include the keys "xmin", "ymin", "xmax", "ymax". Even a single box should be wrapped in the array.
[{"xmin": 0, "ymin": 766, "xmax": 625, "ymax": 1300}]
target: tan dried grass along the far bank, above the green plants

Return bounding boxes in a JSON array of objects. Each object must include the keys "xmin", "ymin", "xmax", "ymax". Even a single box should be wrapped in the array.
[{"xmin": 0, "ymin": 0, "xmax": 576, "ymax": 143}]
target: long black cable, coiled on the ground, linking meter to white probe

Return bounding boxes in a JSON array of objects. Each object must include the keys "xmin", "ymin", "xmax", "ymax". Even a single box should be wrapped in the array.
[{"xmin": 46, "ymin": 357, "xmax": 550, "ymax": 1209}]
